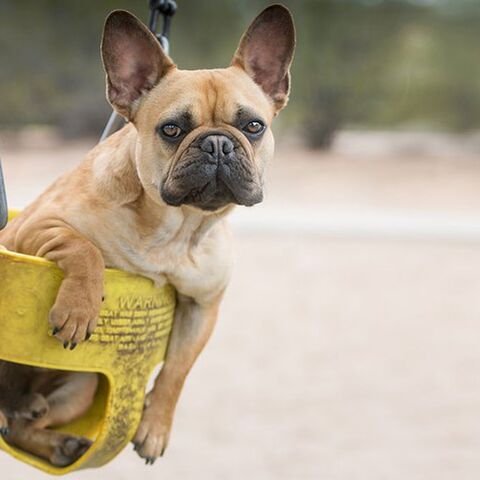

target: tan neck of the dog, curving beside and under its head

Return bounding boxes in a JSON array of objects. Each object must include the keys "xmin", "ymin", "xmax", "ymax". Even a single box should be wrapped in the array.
[{"xmin": 91, "ymin": 124, "xmax": 233, "ymax": 246}]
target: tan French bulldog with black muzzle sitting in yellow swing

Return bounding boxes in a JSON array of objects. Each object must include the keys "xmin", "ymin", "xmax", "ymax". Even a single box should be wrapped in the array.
[{"xmin": 0, "ymin": 5, "xmax": 295, "ymax": 465}]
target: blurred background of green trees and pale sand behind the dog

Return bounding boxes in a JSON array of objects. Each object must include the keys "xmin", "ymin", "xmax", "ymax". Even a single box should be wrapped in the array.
[{"xmin": 0, "ymin": 0, "xmax": 480, "ymax": 480}]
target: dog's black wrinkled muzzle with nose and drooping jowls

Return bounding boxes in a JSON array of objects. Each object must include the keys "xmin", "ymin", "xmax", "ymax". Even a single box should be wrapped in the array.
[{"xmin": 160, "ymin": 134, "xmax": 263, "ymax": 211}]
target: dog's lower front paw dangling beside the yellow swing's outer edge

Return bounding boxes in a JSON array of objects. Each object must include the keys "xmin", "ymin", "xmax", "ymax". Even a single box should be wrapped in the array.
[{"xmin": 133, "ymin": 406, "xmax": 171, "ymax": 465}]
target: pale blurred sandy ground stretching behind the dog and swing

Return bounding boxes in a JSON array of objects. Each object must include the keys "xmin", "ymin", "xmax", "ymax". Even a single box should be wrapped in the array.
[{"xmin": 0, "ymin": 131, "xmax": 480, "ymax": 480}]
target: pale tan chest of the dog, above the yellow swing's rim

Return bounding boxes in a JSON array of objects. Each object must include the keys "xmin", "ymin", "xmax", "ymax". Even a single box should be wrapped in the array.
[{"xmin": 80, "ymin": 208, "xmax": 231, "ymax": 303}]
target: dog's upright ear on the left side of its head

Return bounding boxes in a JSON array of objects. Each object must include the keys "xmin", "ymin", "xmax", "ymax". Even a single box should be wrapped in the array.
[{"xmin": 101, "ymin": 10, "xmax": 175, "ymax": 120}]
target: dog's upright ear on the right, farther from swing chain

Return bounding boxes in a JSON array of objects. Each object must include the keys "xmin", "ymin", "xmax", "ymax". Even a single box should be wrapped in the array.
[{"xmin": 232, "ymin": 5, "xmax": 295, "ymax": 112}]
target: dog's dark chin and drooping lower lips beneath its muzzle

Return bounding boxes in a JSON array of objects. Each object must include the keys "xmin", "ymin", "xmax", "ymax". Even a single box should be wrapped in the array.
[{"xmin": 160, "ymin": 180, "xmax": 263, "ymax": 212}]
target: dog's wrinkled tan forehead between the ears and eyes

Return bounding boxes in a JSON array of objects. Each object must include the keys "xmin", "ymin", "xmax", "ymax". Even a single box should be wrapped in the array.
[{"xmin": 137, "ymin": 67, "xmax": 273, "ymax": 130}]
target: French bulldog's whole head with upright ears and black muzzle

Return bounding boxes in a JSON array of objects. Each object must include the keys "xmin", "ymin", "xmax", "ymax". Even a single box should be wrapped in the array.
[{"xmin": 102, "ymin": 5, "xmax": 295, "ymax": 212}]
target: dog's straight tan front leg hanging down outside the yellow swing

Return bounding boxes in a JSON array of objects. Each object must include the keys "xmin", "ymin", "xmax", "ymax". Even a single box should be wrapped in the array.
[{"xmin": 133, "ymin": 296, "xmax": 221, "ymax": 463}]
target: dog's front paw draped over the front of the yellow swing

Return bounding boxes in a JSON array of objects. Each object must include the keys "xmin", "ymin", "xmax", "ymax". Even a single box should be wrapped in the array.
[{"xmin": 49, "ymin": 282, "xmax": 102, "ymax": 350}]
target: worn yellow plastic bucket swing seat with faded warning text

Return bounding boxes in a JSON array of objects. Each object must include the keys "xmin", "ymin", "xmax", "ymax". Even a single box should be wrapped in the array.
[{"xmin": 0, "ymin": 212, "xmax": 175, "ymax": 475}]
